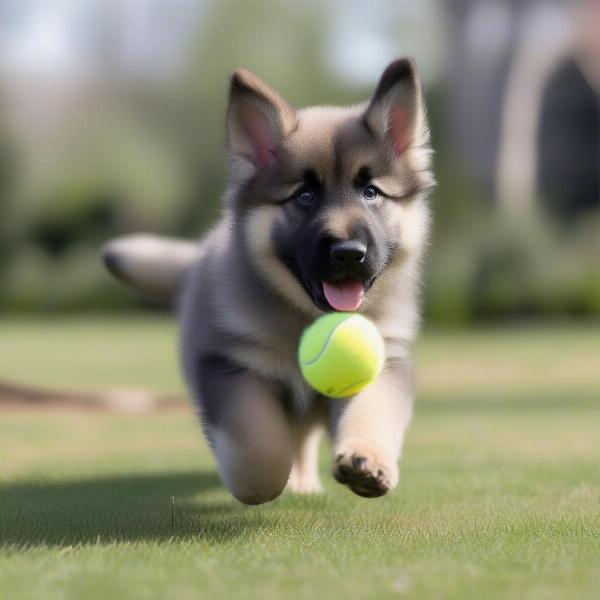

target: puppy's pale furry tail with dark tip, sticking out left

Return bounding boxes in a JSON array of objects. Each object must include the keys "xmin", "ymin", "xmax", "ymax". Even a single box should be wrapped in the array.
[{"xmin": 102, "ymin": 234, "xmax": 202, "ymax": 300}]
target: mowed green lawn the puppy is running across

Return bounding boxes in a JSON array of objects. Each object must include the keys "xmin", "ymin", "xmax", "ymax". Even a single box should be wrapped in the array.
[{"xmin": 0, "ymin": 317, "xmax": 600, "ymax": 600}]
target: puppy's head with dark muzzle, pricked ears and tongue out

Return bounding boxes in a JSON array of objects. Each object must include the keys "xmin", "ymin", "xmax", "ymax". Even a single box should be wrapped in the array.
[{"xmin": 228, "ymin": 59, "xmax": 433, "ymax": 314}]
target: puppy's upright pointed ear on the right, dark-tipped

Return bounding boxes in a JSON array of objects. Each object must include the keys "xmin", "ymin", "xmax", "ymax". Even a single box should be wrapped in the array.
[{"xmin": 365, "ymin": 58, "xmax": 428, "ymax": 156}]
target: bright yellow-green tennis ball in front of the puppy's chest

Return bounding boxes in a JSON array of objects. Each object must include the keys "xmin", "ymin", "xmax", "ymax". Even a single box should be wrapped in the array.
[{"xmin": 298, "ymin": 312, "xmax": 385, "ymax": 398}]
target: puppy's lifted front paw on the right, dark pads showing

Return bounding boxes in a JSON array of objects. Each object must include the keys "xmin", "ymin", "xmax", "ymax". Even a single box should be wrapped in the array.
[{"xmin": 333, "ymin": 442, "xmax": 398, "ymax": 498}]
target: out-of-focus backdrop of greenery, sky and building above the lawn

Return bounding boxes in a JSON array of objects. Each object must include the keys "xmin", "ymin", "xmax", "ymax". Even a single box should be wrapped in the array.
[{"xmin": 0, "ymin": 0, "xmax": 600, "ymax": 325}]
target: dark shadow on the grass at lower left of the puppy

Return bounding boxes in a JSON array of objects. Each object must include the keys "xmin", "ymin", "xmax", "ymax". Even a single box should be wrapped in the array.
[{"xmin": 0, "ymin": 472, "xmax": 272, "ymax": 548}]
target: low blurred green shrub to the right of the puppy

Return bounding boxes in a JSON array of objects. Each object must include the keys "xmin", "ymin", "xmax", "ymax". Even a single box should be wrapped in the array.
[{"xmin": 426, "ymin": 212, "xmax": 600, "ymax": 324}]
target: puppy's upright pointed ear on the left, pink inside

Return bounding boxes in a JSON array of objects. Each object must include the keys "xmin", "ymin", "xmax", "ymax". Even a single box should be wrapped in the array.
[{"xmin": 227, "ymin": 69, "xmax": 297, "ymax": 175}]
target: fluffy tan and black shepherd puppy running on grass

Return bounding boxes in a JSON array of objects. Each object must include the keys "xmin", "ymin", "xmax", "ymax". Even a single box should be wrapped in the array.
[{"xmin": 104, "ymin": 59, "xmax": 433, "ymax": 504}]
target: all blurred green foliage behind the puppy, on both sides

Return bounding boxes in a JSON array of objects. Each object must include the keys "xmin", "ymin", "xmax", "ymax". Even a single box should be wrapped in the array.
[{"xmin": 0, "ymin": 0, "xmax": 600, "ymax": 324}]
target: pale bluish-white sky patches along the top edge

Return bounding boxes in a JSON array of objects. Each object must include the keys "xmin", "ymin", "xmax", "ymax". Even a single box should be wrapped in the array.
[{"xmin": 0, "ymin": 0, "xmax": 443, "ymax": 85}]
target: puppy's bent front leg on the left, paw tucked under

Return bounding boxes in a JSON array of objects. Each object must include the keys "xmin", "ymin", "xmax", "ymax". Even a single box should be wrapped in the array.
[{"xmin": 198, "ymin": 357, "xmax": 293, "ymax": 504}]
